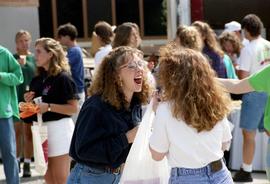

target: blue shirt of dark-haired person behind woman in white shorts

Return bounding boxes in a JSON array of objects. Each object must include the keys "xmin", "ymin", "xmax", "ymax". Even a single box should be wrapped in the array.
[{"xmin": 67, "ymin": 46, "xmax": 84, "ymax": 93}]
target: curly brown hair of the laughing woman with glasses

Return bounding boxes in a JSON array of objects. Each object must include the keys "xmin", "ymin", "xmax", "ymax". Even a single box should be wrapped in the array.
[{"xmin": 88, "ymin": 46, "xmax": 151, "ymax": 109}]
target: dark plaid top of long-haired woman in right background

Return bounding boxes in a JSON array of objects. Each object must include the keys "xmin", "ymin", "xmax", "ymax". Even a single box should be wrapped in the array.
[{"xmin": 203, "ymin": 46, "xmax": 227, "ymax": 78}]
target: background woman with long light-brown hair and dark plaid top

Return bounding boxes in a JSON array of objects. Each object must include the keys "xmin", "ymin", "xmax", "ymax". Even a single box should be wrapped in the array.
[{"xmin": 192, "ymin": 21, "xmax": 227, "ymax": 78}]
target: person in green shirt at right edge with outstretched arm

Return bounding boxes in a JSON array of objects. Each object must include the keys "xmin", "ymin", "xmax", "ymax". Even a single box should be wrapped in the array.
[{"xmin": 218, "ymin": 64, "xmax": 270, "ymax": 181}]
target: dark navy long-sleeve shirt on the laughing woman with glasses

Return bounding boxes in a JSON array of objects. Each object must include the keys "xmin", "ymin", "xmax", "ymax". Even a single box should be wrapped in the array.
[{"xmin": 69, "ymin": 95, "xmax": 142, "ymax": 168}]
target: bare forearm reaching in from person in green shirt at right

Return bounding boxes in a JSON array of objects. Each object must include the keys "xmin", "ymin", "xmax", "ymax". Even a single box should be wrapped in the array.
[{"xmin": 218, "ymin": 78, "xmax": 254, "ymax": 94}]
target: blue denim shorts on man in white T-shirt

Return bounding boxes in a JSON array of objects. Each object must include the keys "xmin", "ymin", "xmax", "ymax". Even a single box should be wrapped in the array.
[{"xmin": 240, "ymin": 92, "xmax": 268, "ymax": 131}]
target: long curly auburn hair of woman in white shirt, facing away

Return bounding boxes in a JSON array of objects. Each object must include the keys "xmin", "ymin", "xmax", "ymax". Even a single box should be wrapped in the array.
[{"xmin": 158, "ymin": 46, "xmax": 230, "ymax": 132}]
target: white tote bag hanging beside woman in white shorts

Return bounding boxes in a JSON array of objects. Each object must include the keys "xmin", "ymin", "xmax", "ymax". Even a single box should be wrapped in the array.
[{"xmin": 31, "ymin": 97, "xmax": 48, "ymax": 175}]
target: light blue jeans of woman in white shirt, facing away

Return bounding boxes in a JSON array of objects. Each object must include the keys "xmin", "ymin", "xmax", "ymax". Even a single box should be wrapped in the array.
[{"xmin": 169, "ymin": 160, "xmax": 233, "ymax": 184}]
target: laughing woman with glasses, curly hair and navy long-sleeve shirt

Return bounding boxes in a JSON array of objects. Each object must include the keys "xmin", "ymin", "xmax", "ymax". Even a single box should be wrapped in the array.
[{"xmin": 68, "ymin": 46, "xmax": 150, "ymax": 184}]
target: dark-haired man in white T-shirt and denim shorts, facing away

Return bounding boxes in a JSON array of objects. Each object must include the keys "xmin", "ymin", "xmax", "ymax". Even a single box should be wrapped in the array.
[{"xmin": 233, "ymin": 14, "xmax": 270, "ymax": 182}]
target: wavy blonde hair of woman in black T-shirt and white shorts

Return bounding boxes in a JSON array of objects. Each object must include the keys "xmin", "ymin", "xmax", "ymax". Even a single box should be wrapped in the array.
[{"xmin": 35, "ymin": 38, "xmax": 70, "ymax": 76}]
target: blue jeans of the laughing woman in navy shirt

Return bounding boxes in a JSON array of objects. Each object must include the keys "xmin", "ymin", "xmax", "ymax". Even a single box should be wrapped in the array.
[{"xmin": 67, "ymin": 163, "xmax": 120, "ymax": 184}]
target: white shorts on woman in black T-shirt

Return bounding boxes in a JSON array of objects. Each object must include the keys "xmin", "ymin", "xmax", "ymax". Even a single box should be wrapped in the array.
[{"xmin": 44, "ymin": 118, "xmax": 74, "ymax": 157}]
